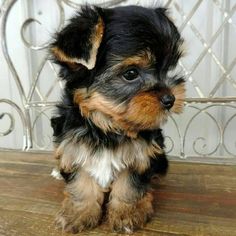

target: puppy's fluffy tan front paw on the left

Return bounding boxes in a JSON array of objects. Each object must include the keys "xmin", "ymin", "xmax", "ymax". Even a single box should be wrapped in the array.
[{"xmin": 55, "ymin": 198, "xmax": 101, "ymax": 234}]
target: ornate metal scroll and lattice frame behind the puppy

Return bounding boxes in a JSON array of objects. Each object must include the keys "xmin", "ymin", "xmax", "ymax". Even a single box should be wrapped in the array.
[{"xmin": 0, "ymin": 0, "xmax": 236, "ymax": 164}]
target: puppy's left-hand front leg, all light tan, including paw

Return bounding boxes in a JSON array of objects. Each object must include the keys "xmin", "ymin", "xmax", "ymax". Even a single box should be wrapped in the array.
[{"xmin": 56, "ymin": 170, "xmax": 104, "ymax": 233}]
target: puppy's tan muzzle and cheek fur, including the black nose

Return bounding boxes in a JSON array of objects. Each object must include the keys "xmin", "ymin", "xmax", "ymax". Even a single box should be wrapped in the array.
[{"xmin": 74, "ymin": 83, "xmax": 185, "ymax": 137}]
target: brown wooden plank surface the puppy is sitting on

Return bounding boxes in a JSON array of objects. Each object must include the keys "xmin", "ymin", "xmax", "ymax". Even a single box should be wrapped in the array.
[{"xmin": 0, "ymin": 152, "xmax": 236, "ymax": 236}]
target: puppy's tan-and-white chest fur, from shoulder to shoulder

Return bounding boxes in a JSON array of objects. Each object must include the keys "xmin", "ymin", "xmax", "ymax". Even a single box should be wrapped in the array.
[{"xmin": 58, "ymin": 136, "xmax": 156, "ymax": 188}]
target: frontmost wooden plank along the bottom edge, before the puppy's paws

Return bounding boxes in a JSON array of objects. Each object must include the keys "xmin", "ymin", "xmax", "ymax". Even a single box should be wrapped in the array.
[{"xmin": 0, "ymin": 209, "xmax": 184, "ymax": 236}]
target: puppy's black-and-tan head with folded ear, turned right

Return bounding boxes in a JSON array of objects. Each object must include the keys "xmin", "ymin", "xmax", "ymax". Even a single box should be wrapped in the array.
[{"xmin": 51, "ymin": 6, "xmax": 185, "ymax": 137}]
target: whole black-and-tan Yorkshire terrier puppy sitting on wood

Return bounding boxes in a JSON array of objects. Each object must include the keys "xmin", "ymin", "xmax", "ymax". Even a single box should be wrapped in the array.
[{"xmin": 50, "ymin": 6, "xmax": 185, "ymax": 233}]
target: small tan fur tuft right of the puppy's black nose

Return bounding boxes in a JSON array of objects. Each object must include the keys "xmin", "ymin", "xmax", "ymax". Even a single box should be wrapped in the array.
[{"xmin": 171, "ymin": 83, "xmax": 186, "ymax": 114}]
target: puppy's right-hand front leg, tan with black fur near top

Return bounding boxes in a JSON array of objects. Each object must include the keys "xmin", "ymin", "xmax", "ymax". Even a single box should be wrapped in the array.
[{"xmin": 107, "ymin": 170, "xmax": 153, "ymax": 233}]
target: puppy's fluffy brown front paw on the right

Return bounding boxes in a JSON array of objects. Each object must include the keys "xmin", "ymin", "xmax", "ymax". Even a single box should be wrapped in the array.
[{"xmin": 107, "ymin": 195, "xmax": 153, "ymax": 233}]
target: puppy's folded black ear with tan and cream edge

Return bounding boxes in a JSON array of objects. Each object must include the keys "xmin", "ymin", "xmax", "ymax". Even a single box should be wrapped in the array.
[{"xmin": 51, "ymin": 6, "xmax": 104, "ymax": 70}]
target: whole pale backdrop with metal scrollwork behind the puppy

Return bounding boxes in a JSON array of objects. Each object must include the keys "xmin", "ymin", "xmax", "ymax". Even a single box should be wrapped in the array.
[{"xmin": 0, "ymin": 0, "xmax": 236, "ymax": 164}]
